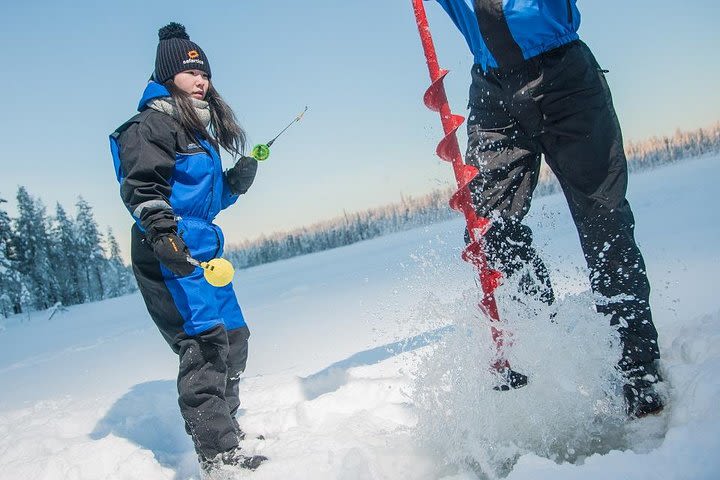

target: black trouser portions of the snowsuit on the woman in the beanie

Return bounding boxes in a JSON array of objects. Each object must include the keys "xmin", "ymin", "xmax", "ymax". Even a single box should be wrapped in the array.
[{"xmin": 131, "ymin": 226, "xmax": 250, "ymax": 459}]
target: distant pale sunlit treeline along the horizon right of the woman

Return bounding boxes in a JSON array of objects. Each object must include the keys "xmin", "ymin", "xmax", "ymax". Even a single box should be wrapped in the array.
[{"xmin": 225, "ymin": 123, "xmax": 720, "ymax": 268}]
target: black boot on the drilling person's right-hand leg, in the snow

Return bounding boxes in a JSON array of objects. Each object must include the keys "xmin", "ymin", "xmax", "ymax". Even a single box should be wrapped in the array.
[{"xmin": 623, "ymin": 363, "xmax": 664, "ymax": 418}]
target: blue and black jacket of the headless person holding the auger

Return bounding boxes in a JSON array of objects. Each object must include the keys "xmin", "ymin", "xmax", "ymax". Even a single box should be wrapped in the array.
[{"xmin": 430, "ymin": 0, "xmax": 580, "ymax": 70}]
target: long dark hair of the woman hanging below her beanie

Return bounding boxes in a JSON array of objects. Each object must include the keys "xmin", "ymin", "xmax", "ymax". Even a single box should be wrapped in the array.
[{"xmin": 164, "ymin": 78, "xmax": 246, "ymax": 157}]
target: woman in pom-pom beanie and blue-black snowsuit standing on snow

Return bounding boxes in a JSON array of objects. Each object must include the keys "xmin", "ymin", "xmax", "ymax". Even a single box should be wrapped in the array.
[{"xmin": 110, "ymin": 23, "xmax": 265, "ymax": 472}]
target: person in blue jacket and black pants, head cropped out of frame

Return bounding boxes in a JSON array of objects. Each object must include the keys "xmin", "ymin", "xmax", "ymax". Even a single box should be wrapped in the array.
[{"xmin": 428, "ymin": 0, "xmax": 663, "ymax": 416}]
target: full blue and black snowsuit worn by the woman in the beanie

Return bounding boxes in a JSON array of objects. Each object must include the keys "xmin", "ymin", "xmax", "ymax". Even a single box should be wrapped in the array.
[{"xmin": 110, "ymin": 82, "xmax": 250, "ymax": 459}]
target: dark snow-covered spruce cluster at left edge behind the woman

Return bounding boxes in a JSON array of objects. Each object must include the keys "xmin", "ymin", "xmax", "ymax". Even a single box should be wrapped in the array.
[{"xmin": 0, "ymin": 187, "xmax": 137, "ymax": 317}]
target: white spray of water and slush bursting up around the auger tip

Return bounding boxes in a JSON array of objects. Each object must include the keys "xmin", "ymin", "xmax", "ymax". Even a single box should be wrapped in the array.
[{"xmin": 404, "ymin": 242, "xmax": 624, "ymax": 479}]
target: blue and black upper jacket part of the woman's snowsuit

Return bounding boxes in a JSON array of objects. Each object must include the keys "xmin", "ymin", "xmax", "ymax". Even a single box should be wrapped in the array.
[{"xmin": 110, "ymin": 82, "xmax": 238, "ymax": 236}]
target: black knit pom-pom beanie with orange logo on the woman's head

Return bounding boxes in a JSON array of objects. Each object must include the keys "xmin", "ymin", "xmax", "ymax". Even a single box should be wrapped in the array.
[{"xmin": 153, "ymin": 22, "xmax": 211, "ymax": 83}]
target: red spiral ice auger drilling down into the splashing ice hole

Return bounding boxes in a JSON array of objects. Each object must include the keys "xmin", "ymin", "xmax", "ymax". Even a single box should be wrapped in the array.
[{"xmin": 413, "ymin": 0, "xmax": 527, "ymax": 390}]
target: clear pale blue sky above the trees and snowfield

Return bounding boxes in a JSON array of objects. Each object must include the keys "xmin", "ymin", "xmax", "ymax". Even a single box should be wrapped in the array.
[{"xmin": 0, "ymin": 0, "xmax": 720, "ymax": 254}]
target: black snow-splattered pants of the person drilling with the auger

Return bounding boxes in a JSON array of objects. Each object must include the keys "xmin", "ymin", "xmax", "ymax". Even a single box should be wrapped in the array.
[{"xmin": 466, "ymin": 41, "xmax": 659, "ymax": 371}]
